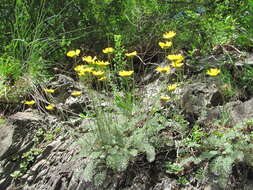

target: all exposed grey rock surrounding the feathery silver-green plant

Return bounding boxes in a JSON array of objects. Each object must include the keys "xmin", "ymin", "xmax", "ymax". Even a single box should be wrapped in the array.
[{"xmin": 0, "ymin": 73, "xmax": 253, "ymax": 190}]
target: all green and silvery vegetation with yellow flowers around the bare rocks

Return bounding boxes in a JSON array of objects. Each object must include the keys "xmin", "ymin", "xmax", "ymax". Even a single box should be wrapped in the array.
[{"xmin": 0, "ymin": 0, "xmax": 253, "ymax": 188}]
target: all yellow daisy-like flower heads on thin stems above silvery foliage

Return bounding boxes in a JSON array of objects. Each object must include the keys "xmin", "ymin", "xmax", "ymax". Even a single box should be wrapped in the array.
[{"xmin": 24, "ymin": 36, "xmax": 221, "ymax": 110}]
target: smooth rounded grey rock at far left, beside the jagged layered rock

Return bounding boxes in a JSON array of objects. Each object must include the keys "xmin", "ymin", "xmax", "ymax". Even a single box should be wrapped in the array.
[{"xmin": 0, "ymin": 110, "xmax": 43, "ymax": 188}]
